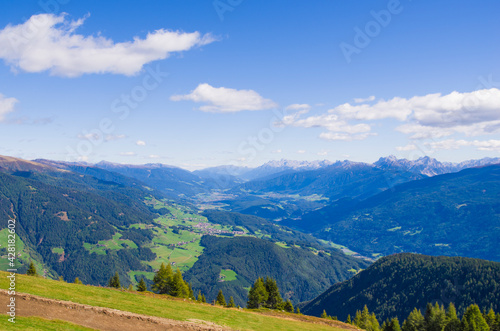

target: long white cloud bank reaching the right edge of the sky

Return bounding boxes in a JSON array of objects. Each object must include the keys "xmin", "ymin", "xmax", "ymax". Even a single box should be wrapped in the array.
[{"xmin": 281, "ymin": 88, "xmax": 500, "ymax": 141}]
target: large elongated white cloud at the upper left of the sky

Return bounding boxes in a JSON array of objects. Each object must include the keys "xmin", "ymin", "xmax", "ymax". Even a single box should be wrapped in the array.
[{"xmin": 0, "ymin": 14, "xmax": 215, "ymax": 77}]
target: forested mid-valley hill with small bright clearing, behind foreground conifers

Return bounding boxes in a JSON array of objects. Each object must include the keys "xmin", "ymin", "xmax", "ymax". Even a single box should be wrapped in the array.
[{"xmin": 186, "ymin": 236, "xmax": 368, "ymax": 306}]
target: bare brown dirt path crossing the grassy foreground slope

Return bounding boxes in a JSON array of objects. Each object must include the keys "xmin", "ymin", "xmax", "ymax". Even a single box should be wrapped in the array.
[{"xmin": 0, "ymin": 290, "xmax": 230, "ymax": 331}]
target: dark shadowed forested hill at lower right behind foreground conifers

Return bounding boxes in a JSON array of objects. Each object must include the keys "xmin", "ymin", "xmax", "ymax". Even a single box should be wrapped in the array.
[{"xmin": 301, "ymin": 253, "xmax": 500, "ymax": 321}]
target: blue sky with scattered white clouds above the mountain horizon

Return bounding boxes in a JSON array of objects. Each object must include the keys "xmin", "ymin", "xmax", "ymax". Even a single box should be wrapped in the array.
[{"xmin": 0, "ymin": 0, "xmax": 500, "ymax": 169}]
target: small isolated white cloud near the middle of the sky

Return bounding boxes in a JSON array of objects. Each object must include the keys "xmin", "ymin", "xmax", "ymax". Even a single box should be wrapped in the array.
[{"xmin": 170, "ymin": 84, "xmax": 278, "ymax": 113}]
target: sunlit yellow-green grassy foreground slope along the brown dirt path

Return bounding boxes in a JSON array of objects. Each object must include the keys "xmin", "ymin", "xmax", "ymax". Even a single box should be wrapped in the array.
[{"xmin": 0, "ymin": 272, "xmax": 354, "ymax": 331}]
